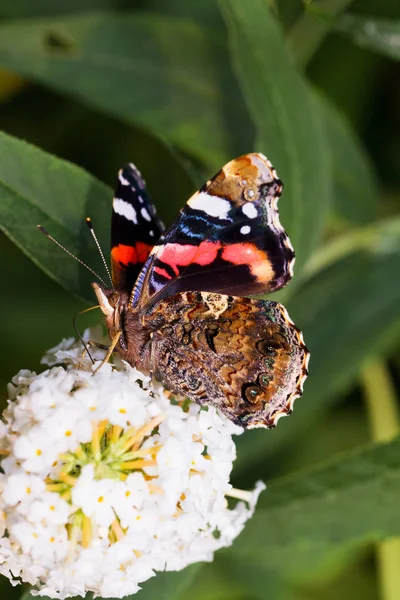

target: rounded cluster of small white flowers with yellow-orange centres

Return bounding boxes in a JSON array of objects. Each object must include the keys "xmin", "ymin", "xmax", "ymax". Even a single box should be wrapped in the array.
[{"xmin": 0, "ymin": 340, "xmax": 265, "ymax": 598}]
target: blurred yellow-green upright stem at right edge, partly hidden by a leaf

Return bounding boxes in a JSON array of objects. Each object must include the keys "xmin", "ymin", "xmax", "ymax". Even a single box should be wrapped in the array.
[{"xmin": 362, "ymin": 359, "xmax": 400, "ymax": 600}]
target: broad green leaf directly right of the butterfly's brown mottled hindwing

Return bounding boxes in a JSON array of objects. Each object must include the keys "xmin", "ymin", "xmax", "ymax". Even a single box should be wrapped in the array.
[{"xmin": 235, "ymin": 218, "xmax": 400, "ymax": 474}]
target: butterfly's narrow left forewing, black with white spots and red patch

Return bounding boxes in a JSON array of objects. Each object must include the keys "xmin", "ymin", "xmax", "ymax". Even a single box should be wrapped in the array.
[{"xmin": 111, "ymin": 164, "xmax": 164, "ymax": 293}]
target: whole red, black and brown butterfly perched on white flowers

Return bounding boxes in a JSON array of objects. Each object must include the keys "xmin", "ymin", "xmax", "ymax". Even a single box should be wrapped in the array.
[{"xmin": 92, "ymin": 153, "xmax": 309, "ymax": 428}]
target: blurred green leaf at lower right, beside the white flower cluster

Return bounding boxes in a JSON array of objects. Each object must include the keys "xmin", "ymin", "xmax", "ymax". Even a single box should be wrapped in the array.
[{"xmin": 230, "ymin": 436, "xmax": 400, "ymax": 574}]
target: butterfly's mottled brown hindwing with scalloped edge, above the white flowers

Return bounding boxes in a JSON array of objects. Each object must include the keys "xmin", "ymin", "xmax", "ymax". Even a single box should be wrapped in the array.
[{"xmin": 143, "ymin": 292, "xmax": 309, "ymax": 428}]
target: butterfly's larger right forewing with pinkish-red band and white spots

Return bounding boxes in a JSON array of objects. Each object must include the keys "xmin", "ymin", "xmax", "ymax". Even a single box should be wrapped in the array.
[{"xmin": 132, "ymin": 154, "xmax": 294, "ymax": 307}]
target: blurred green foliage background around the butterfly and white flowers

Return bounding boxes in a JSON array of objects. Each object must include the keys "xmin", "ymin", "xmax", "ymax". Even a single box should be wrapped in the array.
[{"xmin": 0, "ymin": 0, "xmax": 400, "ymax": 600}]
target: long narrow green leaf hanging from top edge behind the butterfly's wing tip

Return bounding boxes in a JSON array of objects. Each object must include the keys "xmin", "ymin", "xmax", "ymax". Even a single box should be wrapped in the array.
[{"xmin": 221, "ymin": 0, "xmax": 331, "ymax": 269}]
